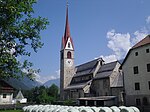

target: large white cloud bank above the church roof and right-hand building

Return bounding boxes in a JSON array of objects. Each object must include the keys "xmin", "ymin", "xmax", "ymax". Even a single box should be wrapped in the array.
[{"xmin": 102, "ymin": 16, "xmax": 150, "ymax": 62}]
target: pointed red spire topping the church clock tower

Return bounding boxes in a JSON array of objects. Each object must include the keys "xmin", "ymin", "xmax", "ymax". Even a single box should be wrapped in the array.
[{"xmin": 62, "ymin": 1, "xmax": 74, "ymax": 49}]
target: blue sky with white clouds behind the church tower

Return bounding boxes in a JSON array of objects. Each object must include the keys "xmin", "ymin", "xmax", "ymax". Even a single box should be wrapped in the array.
[{"xmin": 29, "ymin": 0, "xmax": 150, "ymax": 82}]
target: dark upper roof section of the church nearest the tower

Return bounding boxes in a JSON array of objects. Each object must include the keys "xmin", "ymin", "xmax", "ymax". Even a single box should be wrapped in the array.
[{"xmin": 74, "ymin": 58, "xmax": 103, "ymax": 77}]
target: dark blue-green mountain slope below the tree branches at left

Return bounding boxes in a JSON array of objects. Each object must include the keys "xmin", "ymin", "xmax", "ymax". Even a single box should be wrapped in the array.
[{"xmin": 5, "ymin": 76, "xmax": 42, "ymax": 90}]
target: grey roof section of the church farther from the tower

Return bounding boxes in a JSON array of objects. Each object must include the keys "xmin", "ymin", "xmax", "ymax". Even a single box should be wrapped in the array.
[{"xmin": 94, "ymin": 61, "xmax": 118, "ymax": 79}]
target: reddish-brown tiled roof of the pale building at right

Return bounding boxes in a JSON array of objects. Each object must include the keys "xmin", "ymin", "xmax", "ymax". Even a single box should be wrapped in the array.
[{"xmin": 132, "ymin": 35, "xmax": 150, "ymax": 49}]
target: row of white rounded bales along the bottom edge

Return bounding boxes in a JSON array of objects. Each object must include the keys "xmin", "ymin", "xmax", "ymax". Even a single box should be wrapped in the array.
[{"xmin": 22, "ymin": 105, "xmax": 140, "ymax": 112}]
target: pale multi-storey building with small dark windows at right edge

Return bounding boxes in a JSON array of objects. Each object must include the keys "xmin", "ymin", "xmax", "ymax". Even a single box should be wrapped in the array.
[{"xmin": 121, "ymin": 35, "xmax": 150, "ymax": 106}]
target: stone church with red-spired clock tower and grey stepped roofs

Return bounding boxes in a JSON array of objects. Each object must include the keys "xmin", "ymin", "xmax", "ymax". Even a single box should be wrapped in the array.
[{"xmin": 60, "ymin": 5, "xmax": 123, "ymax": 106}]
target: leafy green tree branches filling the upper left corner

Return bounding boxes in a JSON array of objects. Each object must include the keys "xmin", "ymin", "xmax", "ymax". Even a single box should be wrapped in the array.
[{"xmin": 0, "ymin": 0, "xmax": 48, "ymax": 78}]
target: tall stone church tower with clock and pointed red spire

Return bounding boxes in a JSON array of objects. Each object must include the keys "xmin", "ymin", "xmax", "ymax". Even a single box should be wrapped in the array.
[{"xmin": 60, "ymin": 2, "xmax": 74, "ymax": 100}]
